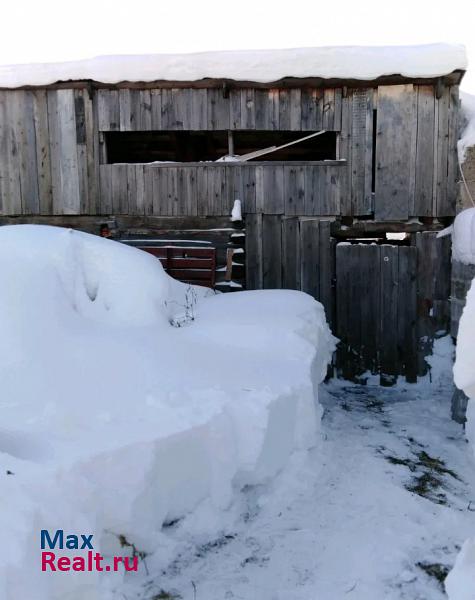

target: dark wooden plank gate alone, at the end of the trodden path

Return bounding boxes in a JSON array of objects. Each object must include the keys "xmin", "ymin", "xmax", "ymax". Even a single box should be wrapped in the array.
[{"xmin": 336, "ymin": 243, "xmax": 417, "ymax": 383}]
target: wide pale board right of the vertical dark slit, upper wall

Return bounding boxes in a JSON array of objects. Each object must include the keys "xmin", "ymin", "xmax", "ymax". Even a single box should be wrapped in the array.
[{"xmin": 375, "ymin": 85, "xmax": 414, "ymax": 221}]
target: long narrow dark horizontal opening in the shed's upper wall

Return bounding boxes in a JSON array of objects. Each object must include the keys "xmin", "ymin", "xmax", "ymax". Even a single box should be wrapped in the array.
[{"xmin": 104, "ymin": 130, "xmax": 337, "ymax": 163}]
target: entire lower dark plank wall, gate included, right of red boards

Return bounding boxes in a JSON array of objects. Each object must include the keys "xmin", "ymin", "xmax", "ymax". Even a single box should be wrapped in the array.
[{"xmin": 246, "ymin": 214, "xmax": 450, "ymax": 385}]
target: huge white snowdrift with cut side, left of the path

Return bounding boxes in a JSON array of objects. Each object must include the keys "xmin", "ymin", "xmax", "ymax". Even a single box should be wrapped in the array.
[{"xmin": 0, "ymin": 225, "xmax": 335, "ymax": 600}]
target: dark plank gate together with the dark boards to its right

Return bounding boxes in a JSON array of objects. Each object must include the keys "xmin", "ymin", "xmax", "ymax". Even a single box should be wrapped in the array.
[{"xmin": 335, "ymin": 232, "xmax": 450, "ymax": 385}]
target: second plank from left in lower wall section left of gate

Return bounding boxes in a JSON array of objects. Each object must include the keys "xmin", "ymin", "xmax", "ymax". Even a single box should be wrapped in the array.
[{"xmin": 262, "ymin": 215, "xmax": 282, "ymax": 289}]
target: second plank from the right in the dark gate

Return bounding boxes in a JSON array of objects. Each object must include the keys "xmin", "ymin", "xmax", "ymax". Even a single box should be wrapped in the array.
[{"xmin": 380, "ymin": 244, "xmax": 399, "ymax": 385}]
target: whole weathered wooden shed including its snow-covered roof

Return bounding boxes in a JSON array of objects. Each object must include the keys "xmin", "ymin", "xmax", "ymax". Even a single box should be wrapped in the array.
[{"xmin": 0, "ymin": 45, "xmax": 465, "ymax": 383}]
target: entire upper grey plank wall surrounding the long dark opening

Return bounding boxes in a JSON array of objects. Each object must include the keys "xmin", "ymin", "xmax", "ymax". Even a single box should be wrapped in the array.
[{"xmin": 0, "ymin": 84, "xmax": 458, "ymax": 220}]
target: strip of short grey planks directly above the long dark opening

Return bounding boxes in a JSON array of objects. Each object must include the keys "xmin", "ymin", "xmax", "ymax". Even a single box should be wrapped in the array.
[{"xmin": 97, "ymin": 88, "xmax": 342, "ymax": 131}]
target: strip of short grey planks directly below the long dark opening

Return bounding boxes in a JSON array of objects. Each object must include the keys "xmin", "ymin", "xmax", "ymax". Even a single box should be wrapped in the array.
[{"xmin": 99, "ymin": 161, "xmax": 344, "ymax": 216}]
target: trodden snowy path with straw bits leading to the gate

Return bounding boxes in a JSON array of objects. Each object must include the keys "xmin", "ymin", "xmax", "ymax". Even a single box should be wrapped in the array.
[{"xmin": 117, "ymin": 346, "xmax": 475, "ymax": 600}]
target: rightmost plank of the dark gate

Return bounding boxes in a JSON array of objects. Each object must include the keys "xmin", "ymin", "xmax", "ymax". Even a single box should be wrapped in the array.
[{"xmin": 398, "ymin": 246, "xmax": 417, "ymax": 383}]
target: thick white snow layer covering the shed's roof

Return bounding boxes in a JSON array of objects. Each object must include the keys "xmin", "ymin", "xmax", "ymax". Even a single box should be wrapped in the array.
[{"xmin": 0, "ymin": 44, "xmax": 467, "ymax": 88}]
